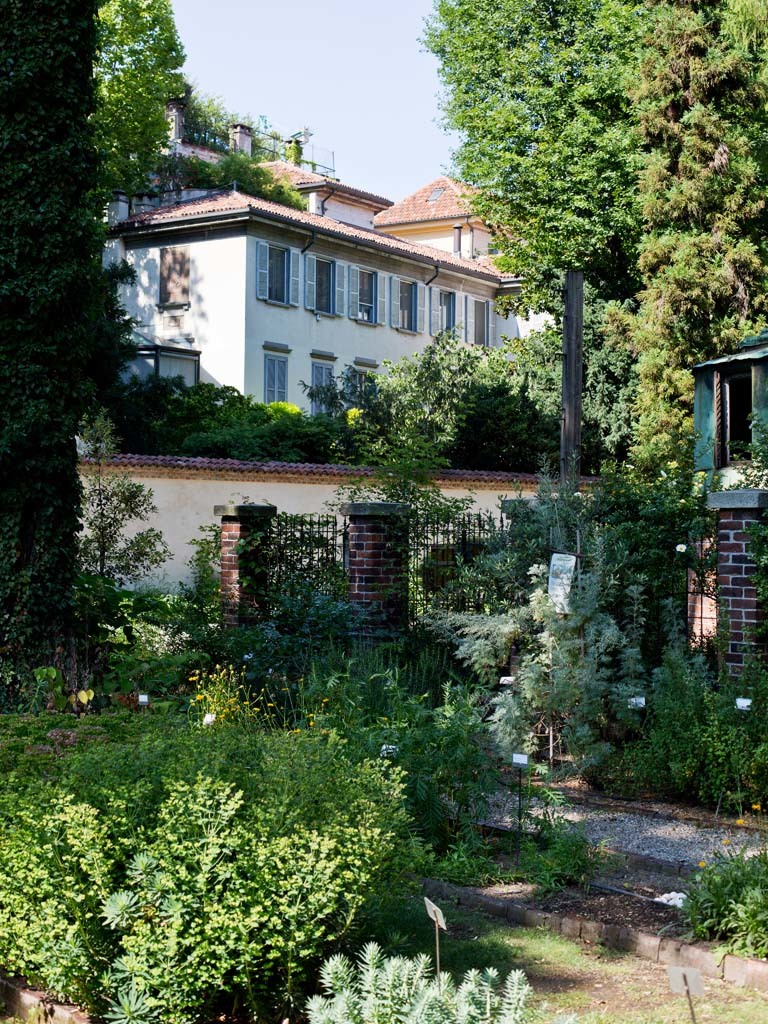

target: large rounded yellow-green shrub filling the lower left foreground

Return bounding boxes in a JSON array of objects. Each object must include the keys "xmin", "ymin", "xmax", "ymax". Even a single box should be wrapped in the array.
[{"xmin": 0, "ymin": 719, "xmax": 411, "ymax": 1024}]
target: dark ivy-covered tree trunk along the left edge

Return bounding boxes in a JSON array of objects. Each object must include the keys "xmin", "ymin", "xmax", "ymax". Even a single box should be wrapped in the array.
[{"xmin": 0, "ymin": 0, "xmax": 100, "ymax": 680}]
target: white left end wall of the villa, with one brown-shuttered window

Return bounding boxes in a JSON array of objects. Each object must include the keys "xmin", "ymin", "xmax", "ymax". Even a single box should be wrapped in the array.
[{"xmin": 123, "ymin": 234, "xmax": 247, "ymax": 391}]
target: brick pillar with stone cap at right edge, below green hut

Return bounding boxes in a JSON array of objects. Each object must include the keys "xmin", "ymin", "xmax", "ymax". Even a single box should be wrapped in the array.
[{"xmin": 707, "ymin": 489, "xmax": 768, "ymax": 675}]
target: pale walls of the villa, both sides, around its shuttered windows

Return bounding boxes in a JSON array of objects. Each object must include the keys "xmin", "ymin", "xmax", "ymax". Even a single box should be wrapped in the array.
[{"xmin": 117, "ymin": 225, "xmax": 517, "ymax": 409}]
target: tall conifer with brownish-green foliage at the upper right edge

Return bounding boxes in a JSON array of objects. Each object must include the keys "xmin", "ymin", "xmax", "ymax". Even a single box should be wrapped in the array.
[{"xmin": 628, "ymin": 0, "xmax": 768, "ymax": 466}]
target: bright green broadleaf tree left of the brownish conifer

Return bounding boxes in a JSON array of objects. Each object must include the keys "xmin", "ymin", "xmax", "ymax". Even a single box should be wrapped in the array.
[{"xmin": 426, "ymin": 0, "xmax": 645, "ymax": 312}]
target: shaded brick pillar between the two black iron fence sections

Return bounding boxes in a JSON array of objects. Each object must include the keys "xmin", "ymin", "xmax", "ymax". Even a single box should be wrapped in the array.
[{"xmin": 341, "ymin": 502, "xmax": 409, "ymax": 633}]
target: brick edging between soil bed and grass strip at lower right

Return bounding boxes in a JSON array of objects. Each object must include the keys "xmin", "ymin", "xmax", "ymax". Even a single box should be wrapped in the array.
[{"xmin": 422, "ymin": 879, "xmax": 768, "ymax": 992}]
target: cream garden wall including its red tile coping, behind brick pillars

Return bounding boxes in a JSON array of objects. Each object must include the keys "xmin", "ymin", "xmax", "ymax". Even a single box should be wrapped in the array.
[{"xmin": 82, "ymin": 455, "xmax": 537, "ymax": 586}]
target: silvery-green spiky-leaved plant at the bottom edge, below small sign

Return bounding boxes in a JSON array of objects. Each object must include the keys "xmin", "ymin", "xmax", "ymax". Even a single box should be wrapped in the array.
[{"xmin": 306, "ymin": 942, "xmax": 530, "ymax": 1024}]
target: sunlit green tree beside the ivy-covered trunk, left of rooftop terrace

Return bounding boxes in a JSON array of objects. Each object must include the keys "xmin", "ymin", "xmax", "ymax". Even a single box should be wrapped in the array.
[{"xmin": 94, "ymin": 0, "xmax": 184, "ymax": 194}]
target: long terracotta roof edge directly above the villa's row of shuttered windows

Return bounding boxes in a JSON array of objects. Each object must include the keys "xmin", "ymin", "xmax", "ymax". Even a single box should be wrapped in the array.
[{"xmin": 111, "ymin": 191, "xmax": 502, "ymax": 287}]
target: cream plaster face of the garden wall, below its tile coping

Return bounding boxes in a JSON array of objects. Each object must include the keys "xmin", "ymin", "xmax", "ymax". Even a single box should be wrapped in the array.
[{"xmin": 108, "ymin": 469, "xmax": 530, "ymax": 587}]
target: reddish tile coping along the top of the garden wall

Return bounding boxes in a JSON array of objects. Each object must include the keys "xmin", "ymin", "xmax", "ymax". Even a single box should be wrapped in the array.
[{"xmin": 81, "ymin": 455, "xmax": 548, "ymax": 487}]
